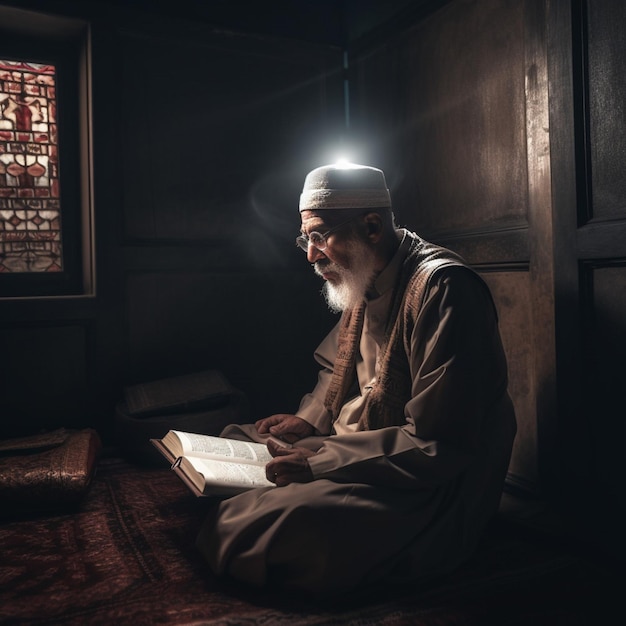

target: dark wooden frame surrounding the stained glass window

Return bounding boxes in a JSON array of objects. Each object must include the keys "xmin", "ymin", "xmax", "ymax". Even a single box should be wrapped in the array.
[{"xmin": 0, "ymin": 7, "xmax": 95, "ymax": 299}]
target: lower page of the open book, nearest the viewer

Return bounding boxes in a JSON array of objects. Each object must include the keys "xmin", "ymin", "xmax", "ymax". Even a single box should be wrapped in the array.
[{"xmin": 181, "ymin": 457, "xmax": 276, "ymax": 494}]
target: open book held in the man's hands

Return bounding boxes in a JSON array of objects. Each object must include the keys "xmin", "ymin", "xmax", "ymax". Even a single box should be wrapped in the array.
[{"xmin": 150, "ymin": 430, "xmax": 276, "ymax": 496}]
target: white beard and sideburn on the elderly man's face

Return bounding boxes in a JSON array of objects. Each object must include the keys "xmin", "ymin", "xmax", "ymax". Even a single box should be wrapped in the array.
[{"xmin": 315, "ymin": 240, "xmax": 376, "ymax": 313}]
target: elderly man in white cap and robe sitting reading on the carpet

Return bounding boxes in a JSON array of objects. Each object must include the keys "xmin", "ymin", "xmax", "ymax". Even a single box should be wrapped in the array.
[{"xmin": 197, "ymin": 164, "xmax": 516, "ymax": 597}]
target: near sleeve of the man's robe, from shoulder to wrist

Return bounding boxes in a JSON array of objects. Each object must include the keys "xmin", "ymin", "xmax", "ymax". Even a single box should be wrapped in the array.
[{"xmin": 309, "ymin": 268, "xmax": 508, "ymax": 488}]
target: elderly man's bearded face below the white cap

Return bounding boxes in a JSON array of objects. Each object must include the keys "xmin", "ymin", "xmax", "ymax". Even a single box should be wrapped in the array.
[{"xmin": 301, "ymin": 211, "xmax": 375, "ymax": 313}]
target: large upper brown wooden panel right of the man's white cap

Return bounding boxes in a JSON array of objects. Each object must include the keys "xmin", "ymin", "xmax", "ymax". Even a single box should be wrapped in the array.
[{"xmin": 352, "ymin": 0, "xmax": 528, "ymax": 237}]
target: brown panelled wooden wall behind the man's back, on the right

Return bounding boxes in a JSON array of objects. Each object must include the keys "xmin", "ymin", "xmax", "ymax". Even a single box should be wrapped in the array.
[{"xmin": 351, "ymin": 0, "xmax": 626, "ymax": 554}]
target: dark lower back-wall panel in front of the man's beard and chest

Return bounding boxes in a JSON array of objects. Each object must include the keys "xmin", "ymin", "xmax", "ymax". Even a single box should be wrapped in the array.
[{"xmin": 127, "ymin": 260, "xmax": 337, "ymax": 419}]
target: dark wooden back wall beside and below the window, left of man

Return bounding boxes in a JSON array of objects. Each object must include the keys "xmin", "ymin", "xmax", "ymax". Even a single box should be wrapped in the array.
[{"xmin": 0, "ymin": 3, "xmax": 344, "ymax": 443}]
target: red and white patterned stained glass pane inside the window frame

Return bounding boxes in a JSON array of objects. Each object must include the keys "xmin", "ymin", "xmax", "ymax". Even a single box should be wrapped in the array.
[{"xmin": 0, "ymin": 59, "xmax": 63, "ymax": 273}]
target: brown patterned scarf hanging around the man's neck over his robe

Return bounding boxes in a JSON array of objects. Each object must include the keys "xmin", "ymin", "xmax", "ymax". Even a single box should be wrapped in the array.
[{"xmin": 324, "ymin": 233, "xmax": 465, "ymax": 430}]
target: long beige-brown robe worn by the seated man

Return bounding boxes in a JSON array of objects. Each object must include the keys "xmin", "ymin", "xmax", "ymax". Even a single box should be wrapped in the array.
[{"xmin": 198, "ymin": 231, "xmax": 516, "ymax": 596}]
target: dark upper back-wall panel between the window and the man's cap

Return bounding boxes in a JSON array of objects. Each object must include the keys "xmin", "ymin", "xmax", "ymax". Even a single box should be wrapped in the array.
[{"xmin": 120, "ymin": 25, "xmax": 343, "ymax": 241}]
